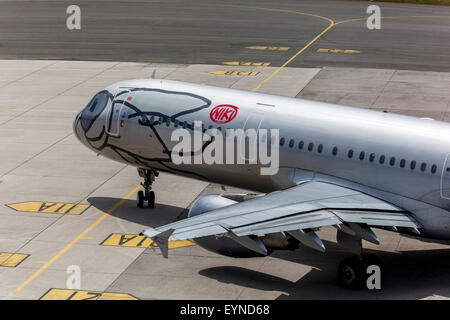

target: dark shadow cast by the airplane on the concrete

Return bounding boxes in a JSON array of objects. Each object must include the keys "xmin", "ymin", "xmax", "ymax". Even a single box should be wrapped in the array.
[{"xmin": 88, "ymin": 197, "xmax": 450, "ymax": 299}]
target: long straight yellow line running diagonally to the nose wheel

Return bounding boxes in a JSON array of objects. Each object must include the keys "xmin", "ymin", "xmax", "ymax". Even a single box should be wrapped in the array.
[{"xmin": 13, "ymin": 185, "xmax": 141, "ymax": 294}]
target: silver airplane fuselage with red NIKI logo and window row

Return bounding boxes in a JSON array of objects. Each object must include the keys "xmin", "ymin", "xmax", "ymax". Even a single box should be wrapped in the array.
[{"xmin": 74, "ymin": 79, "xmax": 450, "ymax": 239}]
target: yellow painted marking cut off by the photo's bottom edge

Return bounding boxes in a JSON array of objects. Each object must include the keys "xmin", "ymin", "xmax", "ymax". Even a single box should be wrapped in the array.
[{"xmin": 40, "ymin": 289, "xmax": 139, "ymax": 300}]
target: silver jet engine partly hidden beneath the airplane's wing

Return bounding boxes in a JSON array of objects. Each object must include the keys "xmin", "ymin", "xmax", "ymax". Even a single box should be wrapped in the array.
[{"xmin": 188, "ymin": 195, "xmax": 299, "ymax": 258}]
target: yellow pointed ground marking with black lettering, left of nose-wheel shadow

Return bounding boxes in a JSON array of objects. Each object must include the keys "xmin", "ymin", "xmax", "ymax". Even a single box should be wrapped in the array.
[{"xmin": 6, "ymin": 201, "xmax": 90, "ymax": 214}]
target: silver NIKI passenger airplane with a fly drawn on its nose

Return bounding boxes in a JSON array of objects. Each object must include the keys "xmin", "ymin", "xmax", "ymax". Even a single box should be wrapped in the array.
[{"xmin": 73, "ymin": 78, "xmax": 450, "ymax": 288}]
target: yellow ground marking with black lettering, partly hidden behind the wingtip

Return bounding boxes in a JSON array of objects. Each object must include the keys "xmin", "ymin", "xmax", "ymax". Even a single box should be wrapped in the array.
[{"xmin": 101, "ymin": 233, "xmax": 195, "ymax": 249}]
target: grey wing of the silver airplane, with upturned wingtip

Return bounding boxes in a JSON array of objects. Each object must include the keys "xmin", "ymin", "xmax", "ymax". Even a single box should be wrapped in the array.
[{"xmin": 144, "ymin": 181, "xmax": 420, "ymax": 257}]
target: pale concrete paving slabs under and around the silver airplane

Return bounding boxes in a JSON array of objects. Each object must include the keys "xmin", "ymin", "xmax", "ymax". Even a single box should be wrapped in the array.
[{"xmin": 0, "ymin": 60, "xmax": 450, "ymax": 299}]
